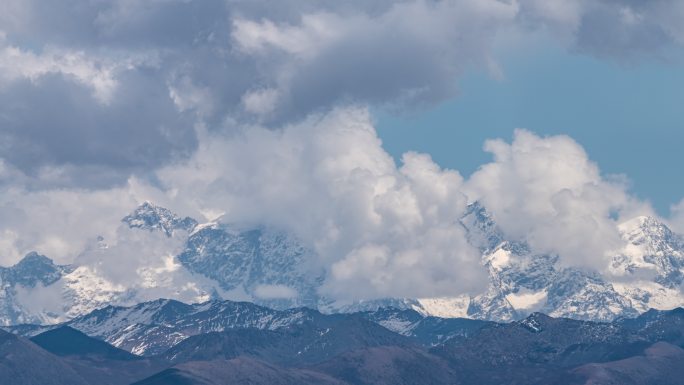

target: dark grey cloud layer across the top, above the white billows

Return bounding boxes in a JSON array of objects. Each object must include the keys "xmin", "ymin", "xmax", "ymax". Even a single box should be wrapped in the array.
[{"xmin": 0, "ymin": 0, "xmax": 684, "ymax": 187}]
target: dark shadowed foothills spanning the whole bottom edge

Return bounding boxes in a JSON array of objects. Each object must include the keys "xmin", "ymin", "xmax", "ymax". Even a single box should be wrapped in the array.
[{"xmin": 0, "ymin": 303, "xmax": 684, "ymax": 385}]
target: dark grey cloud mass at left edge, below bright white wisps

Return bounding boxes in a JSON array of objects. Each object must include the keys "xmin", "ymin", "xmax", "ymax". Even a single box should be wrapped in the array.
[{"xmin": 0, "ymin": 70, "xmax": 196, "ymax": 180}]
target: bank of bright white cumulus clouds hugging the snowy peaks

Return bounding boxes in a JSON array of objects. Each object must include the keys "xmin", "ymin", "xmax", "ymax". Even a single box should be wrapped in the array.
[{"xmin": 0, "ymin": 107, "xmax": 668, "ymax": 300}]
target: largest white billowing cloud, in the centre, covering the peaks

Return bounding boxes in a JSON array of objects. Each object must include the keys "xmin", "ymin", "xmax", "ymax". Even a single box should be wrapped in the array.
[{"xmin": 158, "ymin": 108, "xmax": 485, "ymax": 298}]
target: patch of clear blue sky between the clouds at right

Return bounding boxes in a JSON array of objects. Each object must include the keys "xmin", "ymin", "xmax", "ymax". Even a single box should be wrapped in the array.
[{"xmin": 375, "ymin": 43, "xmax": 684, "ymax": 215}]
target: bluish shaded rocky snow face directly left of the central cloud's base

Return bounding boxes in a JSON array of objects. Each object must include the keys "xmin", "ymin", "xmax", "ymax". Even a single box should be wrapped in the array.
[{"xmin": 178, "ymin": 223, "xmax": 324, "ymax": 309}]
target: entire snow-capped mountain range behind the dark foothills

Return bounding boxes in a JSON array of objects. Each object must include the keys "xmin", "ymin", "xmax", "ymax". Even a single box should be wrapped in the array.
[{"xmin": 0, "ymin": 202, "xmax": 684, "ymax": 325}]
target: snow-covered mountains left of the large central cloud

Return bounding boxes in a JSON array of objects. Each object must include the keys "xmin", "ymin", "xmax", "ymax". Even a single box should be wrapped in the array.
[{"xmin": 0, "ymin": 202, "xmax": 323, "ymax": 325}]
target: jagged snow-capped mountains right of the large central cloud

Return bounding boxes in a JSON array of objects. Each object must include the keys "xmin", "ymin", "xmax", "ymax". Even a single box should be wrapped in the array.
[{"xmin": 454, "ymin": 203, "xmax": 684, "ymax": 321}]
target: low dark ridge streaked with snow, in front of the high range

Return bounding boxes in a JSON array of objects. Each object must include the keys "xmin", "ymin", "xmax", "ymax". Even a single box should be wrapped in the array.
[{"xmin": 10, "ymin": 299, "xmax": 490, "ymax": 356}]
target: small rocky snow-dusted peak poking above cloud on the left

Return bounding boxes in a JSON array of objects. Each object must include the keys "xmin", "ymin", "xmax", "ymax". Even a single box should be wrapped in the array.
[{"xmin": 121, "ymin": 201, "xmax": 197, "ymax": 237}]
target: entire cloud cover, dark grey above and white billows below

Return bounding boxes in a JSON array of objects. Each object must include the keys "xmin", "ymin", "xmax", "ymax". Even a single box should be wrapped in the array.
[{"xmin": 0, "ymin": 0, "xmax": 684, "ymax": 298}]
